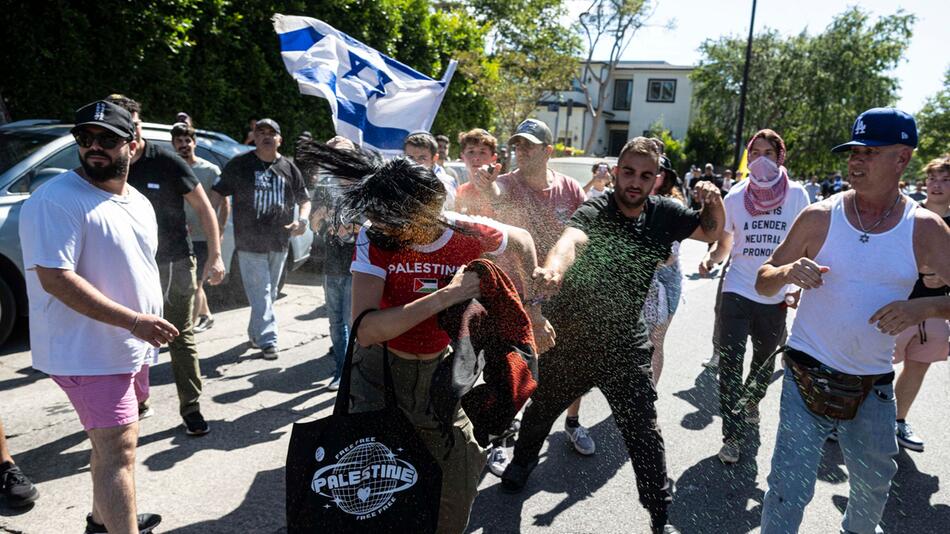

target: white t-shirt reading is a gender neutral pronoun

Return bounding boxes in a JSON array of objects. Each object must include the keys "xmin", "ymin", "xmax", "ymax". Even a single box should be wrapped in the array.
[{"xmin": 722, "ymin": 180, "xmax": 809, "ymax": 304}]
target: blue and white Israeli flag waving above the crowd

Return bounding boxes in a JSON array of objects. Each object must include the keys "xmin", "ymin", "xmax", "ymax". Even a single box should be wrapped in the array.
[{"xmin": 274, "ymin": 15, "xmax": 456, "ymax": 156}]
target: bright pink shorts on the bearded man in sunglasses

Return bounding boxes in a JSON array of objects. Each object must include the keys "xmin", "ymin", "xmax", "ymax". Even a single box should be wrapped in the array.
[{"xmin": 50, "ymin": 365, "xmax": 148, "ymax": 430}]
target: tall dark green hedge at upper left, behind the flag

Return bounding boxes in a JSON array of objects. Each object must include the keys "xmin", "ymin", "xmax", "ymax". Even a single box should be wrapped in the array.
[{"xmin": 0, "ymin": 0, "xmax": 492, "ymax": 151}]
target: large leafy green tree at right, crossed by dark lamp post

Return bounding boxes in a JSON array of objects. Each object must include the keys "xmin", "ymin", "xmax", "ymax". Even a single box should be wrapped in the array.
[{"xmin": 687, "ymin": 7, "xmax": 915, "ymax": 174}]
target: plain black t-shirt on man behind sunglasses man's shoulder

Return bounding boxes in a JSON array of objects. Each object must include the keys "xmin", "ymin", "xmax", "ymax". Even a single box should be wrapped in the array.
[{"xmin": 129, "ymin": 142, "xmax": 198, "ymax": 263}]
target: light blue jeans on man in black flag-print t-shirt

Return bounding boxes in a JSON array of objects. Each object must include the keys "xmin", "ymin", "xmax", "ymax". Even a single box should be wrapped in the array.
[{"xmin": 238, "ymin": 250, "xmax": 287, "ymax": 348}]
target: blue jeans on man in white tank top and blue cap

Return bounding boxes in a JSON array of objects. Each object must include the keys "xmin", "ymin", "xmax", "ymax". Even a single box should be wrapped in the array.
[{"xmin": 761, "ymin": 369, "xmax": 897, "ymax": 534}]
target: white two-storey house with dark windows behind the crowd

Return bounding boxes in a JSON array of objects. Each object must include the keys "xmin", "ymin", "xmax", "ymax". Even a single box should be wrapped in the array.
[{"xmin": 535, "ymin": 61, "xmax": 693, "ymax": 156}]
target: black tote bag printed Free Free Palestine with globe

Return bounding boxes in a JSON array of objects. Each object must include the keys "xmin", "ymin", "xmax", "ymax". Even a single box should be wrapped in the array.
[{"xmin": 286, "ymin": 310, "xmax": 442, "ymax": 534}]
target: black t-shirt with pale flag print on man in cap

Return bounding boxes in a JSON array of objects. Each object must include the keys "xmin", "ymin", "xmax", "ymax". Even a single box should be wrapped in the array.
[{"xmin": 211, "ymin": 152, "xmax": 309, "ymax": 252}]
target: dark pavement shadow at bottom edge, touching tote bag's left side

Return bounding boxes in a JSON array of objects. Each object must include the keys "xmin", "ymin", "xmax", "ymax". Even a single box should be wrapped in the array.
[{"xmin": 162, "ymin": 468, "xmax": 286, "ymax": 534}]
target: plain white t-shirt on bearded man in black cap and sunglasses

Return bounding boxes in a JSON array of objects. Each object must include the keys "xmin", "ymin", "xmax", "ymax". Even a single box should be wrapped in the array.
[{"xmin": 20, "ymin": 171, "xmax": 162, "ymax": 375}]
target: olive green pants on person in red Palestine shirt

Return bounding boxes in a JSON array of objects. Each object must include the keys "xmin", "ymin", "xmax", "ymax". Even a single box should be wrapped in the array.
[{"xmin": 350, "ymin": 348, "xmax": 486, "ymax": 534}]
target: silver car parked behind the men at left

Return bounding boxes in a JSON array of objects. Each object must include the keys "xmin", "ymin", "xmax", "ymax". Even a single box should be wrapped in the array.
[{"xmin": 0, "ymin": 120, "xmax": 313, "ymax": 345}]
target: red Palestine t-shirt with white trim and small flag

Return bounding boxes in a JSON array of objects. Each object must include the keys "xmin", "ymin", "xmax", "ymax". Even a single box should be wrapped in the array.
[{"xmin": 350, "ymin": 212, "xmax": 508, "ymax": 354}]
